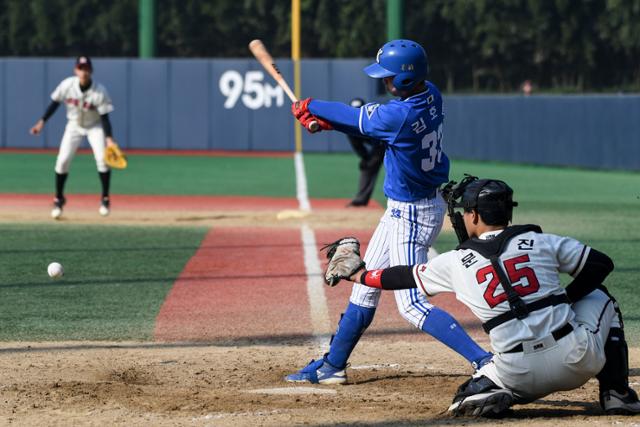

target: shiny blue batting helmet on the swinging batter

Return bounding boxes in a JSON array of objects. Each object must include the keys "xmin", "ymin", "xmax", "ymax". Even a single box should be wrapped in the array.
[{"xmin": 364, "ymin": 40, "xmax": 429, "ymax": 90}]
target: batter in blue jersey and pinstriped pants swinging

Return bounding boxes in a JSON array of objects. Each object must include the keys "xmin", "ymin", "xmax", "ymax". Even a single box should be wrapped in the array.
[{"xmin": 286, "ymin": 40, "xmax": 491, "ymax": 384}]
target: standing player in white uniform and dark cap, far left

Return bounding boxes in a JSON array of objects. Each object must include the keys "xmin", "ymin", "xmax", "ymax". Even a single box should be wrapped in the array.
[{"xmin": 30, "ymin": 56, "xmax": 115, "ymax": 219}]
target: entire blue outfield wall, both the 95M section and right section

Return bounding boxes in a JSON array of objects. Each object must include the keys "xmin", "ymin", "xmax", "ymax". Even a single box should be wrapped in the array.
[{"xmin": 0, "ymin": 58, "xmax": 640, "ymax": 170}]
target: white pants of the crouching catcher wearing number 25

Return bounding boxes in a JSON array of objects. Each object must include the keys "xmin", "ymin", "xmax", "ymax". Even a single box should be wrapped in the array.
[{"xmin": 475, "ymin": 290, "xmax": 621, "ymax": 402}]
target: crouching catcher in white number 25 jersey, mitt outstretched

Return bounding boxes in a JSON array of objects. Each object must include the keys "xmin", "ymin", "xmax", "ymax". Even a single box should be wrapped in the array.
[{"xmin": 326, "ymin": 176, "xmax": 640, "ymax": 416}]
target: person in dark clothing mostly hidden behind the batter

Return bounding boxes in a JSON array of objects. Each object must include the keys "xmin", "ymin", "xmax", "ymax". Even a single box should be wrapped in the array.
[{"xmin": 347, "ymin": 98, "xmax": 385, "ymax": 207}]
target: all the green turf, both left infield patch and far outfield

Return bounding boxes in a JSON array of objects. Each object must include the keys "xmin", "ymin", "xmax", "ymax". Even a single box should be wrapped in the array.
[{"xmin": 0, "ymin": 153, "xmax": 640, "ymax": 345}]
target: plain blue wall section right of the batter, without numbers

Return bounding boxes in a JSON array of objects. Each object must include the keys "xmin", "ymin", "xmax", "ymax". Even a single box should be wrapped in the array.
[{"xmin": 445, "ymin": 95, "xmax": 640, "ymax": 170}]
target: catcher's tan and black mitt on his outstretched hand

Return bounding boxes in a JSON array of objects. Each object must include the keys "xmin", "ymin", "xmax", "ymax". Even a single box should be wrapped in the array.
[{"xmin": 321, "ymin": 237, "xmax": 365, "ymax": 286}]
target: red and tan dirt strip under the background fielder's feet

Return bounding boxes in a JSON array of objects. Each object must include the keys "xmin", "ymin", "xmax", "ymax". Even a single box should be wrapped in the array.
[{"xmin": 0, "ymin": 194, "xmax": 382, "ymax": 229}]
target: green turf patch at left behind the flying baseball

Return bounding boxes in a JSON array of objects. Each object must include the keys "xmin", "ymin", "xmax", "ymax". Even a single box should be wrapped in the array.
[{"xmin": 0, "ymin": 224, "xmax": 206, "ymax": 341}]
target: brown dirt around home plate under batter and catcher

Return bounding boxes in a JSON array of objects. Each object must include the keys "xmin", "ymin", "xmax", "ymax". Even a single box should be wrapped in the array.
[{"xmin": 0, "ymin": 342, "xmax": 640, "ymax": 426}]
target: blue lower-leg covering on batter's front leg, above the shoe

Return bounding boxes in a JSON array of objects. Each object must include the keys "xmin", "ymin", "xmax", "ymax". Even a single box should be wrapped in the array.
[{"xmin": 325, "ymin": 302, "xmax": 376, "ymax": 369}]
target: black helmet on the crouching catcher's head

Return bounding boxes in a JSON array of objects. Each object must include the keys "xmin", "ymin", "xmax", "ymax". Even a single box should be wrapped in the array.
[{"xmin": 454, "ymin": 179, "xmax": 518, "ymax": 225}]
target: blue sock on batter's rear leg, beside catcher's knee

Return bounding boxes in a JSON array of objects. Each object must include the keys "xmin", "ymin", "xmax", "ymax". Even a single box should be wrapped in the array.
[{"xmin": 421, "ymin": 307, "xmax": 493, "ymax": 369}]
